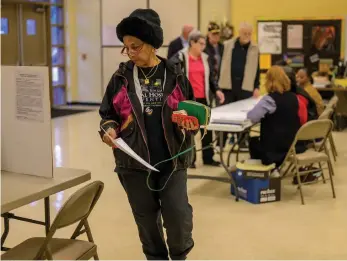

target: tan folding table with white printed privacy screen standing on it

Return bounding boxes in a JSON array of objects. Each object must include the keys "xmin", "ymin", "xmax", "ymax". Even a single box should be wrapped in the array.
[{"xmin": 1, "ymin": 66, "xmax": 91, "ymax": 251}]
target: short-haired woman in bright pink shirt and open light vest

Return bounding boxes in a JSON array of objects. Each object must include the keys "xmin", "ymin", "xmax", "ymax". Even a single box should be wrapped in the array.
[{"xmin": 172, "ymin": 31, "xmax": 224, "ymax": 168}]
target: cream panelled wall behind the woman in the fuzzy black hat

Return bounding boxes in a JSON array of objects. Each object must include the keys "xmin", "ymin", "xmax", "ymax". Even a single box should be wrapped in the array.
[{"xmin": 65, "ymin": 0, "xmax": 230, "ymax": 102}]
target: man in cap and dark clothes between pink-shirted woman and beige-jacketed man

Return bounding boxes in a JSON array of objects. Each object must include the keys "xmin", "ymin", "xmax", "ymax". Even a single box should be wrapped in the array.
[{"xmin": 204, "ymin": 22, "xmax": 224, "ymax": 104}]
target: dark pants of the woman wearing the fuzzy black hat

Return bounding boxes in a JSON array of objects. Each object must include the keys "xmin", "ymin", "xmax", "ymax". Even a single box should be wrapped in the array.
[{"xmin": 118, "ymin": 170, "xmax": 194, "ymax": 260}]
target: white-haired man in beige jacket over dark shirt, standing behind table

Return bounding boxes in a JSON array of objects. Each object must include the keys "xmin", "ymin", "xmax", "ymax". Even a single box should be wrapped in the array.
[{"xmin": 218, "ymin": 23, "xmax": 260, "ymax": 147}]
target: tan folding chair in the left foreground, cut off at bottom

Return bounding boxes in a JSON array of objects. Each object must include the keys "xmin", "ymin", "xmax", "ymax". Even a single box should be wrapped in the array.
[{"xmin": 1, "ymin": 181, "xmax": 104, "ymax": 260}]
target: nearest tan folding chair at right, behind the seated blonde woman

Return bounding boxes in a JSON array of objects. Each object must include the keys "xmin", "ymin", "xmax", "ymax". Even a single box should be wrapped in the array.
[{"xmin": 279, "ymin": 120, "xmax": 336, "ymax": 205}]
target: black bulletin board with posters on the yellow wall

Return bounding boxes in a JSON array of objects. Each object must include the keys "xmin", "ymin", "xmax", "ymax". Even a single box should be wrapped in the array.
[{"xmin": 257, "ymin": 19, "xmax": 342, "ymax": 72}]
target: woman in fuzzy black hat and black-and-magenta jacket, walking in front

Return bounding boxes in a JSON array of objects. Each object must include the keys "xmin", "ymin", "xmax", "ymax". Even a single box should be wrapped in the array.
[{"xmin": 100, "ymin": 9, "xmax": 199, "ymax": 260}]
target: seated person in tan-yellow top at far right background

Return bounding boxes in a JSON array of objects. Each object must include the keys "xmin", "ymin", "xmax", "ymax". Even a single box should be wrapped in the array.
[{"xmin": 296, "ymin": 68, "xmax": 324, "ymax": 116}]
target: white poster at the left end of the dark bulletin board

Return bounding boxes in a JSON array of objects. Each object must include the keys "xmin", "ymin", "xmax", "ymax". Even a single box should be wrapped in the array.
[{"xmin": 258, "ymin": 22, "xmax": 282, "ymax": 54}]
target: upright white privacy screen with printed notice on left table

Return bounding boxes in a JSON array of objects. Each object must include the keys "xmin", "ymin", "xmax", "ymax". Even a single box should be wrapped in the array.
[{"xmin": 1, "ymin": 66, "xmax": 53, "ymax": 178}]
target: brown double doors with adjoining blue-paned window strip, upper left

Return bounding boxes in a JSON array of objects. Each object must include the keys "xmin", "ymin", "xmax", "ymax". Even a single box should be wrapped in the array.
[{"xmin": 1, "ymin": 0, "xmax": 66, "ymax": 106}]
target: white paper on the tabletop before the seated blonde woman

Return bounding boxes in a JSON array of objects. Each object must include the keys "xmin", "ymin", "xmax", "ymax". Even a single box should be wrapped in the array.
[{"xmin": 210, "ymin": 97, "xmax": 261, "ymax": 125}]
